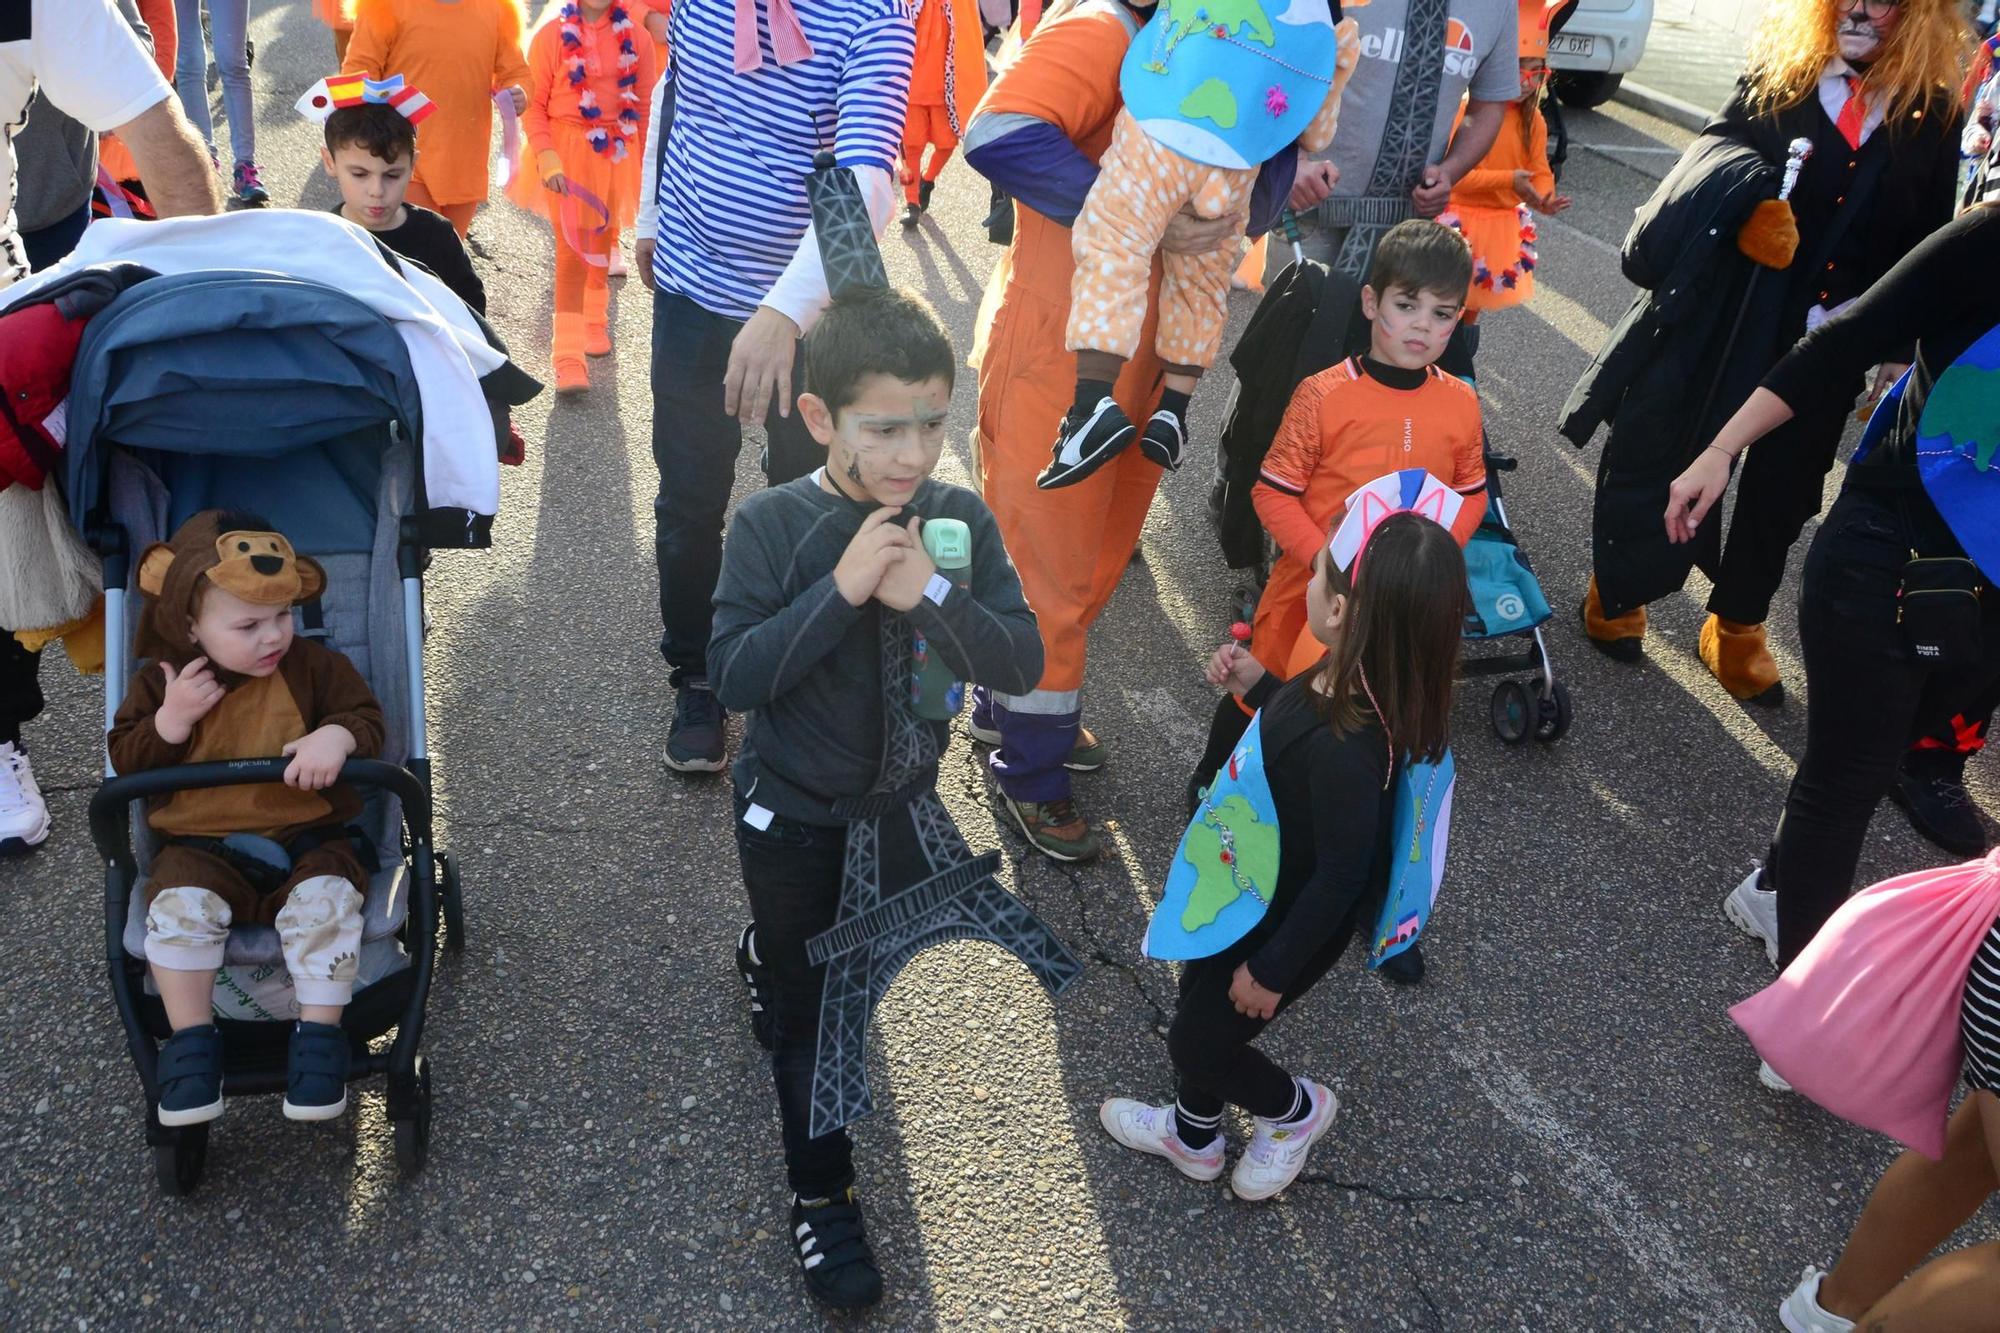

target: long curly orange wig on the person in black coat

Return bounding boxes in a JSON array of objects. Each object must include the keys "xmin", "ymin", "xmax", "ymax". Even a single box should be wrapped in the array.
[{"xmin": 1746, "ymin": 0, "xmax": 1974, "ymax": 126}]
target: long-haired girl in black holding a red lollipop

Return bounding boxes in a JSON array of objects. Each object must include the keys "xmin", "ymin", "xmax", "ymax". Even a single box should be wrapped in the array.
[{"xmin": 1098, "ymin": 512, "xmax": 1466, "ymax": 1199}]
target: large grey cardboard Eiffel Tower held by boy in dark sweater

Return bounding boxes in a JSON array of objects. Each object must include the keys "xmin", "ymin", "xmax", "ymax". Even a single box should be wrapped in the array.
[{"xmin": 806, "ymin": 152, "xmax": 1082, "ymax": 1137}]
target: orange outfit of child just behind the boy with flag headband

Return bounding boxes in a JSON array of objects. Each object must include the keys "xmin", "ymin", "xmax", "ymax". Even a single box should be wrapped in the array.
[{"xmin": 340, "ymin": 0, "xmax": 528, "ymax": 236}]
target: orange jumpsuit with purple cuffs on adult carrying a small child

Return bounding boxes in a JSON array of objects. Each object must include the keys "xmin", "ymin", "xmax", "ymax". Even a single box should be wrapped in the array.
[{"xmin": 972, "ymin": 4, "xmax": 1160, "ymax": 801}]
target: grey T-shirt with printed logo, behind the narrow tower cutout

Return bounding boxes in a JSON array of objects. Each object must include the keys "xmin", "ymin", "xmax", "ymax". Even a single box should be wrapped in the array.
[{"xmin": 1318, "ymin": 0, "xmax": 1520, "ymax": 198}]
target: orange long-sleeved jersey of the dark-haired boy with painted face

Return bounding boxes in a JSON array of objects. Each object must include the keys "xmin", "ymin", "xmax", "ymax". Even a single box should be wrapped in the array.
[{"xmin": 1250, "ymin": 356, "xmax": 1486, "ymax": 677}]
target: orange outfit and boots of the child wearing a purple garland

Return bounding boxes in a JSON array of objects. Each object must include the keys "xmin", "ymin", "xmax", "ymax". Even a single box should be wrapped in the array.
[{"xmin": 508, "ymin": 10, "xmax": 658, "ymax": 376}]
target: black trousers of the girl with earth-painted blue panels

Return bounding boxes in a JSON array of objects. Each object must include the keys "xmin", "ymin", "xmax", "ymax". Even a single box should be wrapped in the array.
[{"xmin": 1166, "ymin": 913, "xmax": 1356, "ymax": 1121}]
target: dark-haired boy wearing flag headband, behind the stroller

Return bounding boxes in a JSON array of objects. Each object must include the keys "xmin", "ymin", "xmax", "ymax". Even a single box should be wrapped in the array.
[{"xmin": 320, "ymin": 102, "xmax": 486, "ymax": 314}]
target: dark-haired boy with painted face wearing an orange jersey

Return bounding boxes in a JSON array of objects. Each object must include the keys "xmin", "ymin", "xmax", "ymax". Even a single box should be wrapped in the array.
[{"xmin": 1250, "ymin": 218, "xmax": 1486, "ymax": 677}]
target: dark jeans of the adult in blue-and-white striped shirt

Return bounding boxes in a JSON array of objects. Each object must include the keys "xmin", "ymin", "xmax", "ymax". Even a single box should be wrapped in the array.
[{"xmin": 652, "ymin": 290, "xmax": 826, "ymax": 689}]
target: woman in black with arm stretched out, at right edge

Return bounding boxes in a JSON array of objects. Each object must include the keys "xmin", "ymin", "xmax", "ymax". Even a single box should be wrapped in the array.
[{"xmin": 1666, "ymin": 206, "xmax": 2000, "ymax": 969}]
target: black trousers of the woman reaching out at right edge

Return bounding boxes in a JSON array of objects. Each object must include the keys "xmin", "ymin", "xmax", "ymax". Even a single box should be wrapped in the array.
[{"xmin": 1750, "ymin": 482, "xmax": 2000, "ymax": 967}]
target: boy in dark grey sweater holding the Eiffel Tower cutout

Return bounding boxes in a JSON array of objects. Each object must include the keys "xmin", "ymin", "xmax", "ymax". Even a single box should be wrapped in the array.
[{"xmin": 708, "ymin": 290, "xmax": 1042, "ymax": 1307}]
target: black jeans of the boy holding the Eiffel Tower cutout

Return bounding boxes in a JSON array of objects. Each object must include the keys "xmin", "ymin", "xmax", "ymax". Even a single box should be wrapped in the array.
[{"xmin": 736, "ymin": 793, "xmax": 854, "ymax": 1199}]
